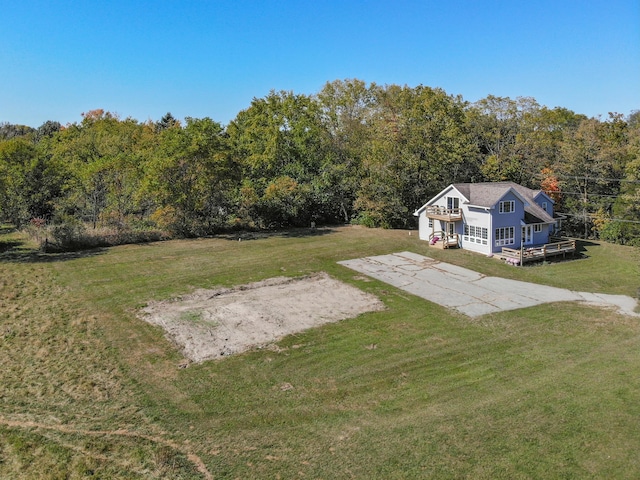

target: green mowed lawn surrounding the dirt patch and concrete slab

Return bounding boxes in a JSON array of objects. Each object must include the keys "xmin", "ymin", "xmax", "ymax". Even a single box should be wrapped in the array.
[{"xmin": 0, "ymin": 227, "xmax": 640, "ymax": 479}]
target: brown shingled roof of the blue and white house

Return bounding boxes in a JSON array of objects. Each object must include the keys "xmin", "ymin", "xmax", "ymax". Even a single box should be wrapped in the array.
[{"xmin": 416, "ymin": 182, "xmax": 554, "ymax": 223}]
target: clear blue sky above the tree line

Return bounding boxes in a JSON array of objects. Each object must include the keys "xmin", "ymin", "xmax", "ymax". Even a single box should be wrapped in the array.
[{"xmin": 0, "ymin": 0, "xmax": 640, "ymax": 127}]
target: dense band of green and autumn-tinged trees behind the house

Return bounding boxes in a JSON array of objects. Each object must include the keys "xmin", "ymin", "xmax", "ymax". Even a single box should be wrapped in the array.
[{"xmin": 0, "ymin": 80, "xmax": 640, "ymax": 249}]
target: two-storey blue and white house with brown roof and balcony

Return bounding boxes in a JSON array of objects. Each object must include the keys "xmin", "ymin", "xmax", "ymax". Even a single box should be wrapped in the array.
[{"xmin": 414, "ymin": 182, "xmax": 560, "ymax": 255}]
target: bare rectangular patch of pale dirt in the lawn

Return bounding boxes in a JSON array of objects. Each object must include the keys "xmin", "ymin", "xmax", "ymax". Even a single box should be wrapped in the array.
[{"xmin": 141, "ymin": 273, "xmax": 384, "ymax": 362}]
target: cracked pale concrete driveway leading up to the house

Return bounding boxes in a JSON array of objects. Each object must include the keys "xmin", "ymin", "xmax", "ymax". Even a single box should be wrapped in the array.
[{"xmin": 338, "ymin": 252, "xmax": 640, "ymax": 317}]
